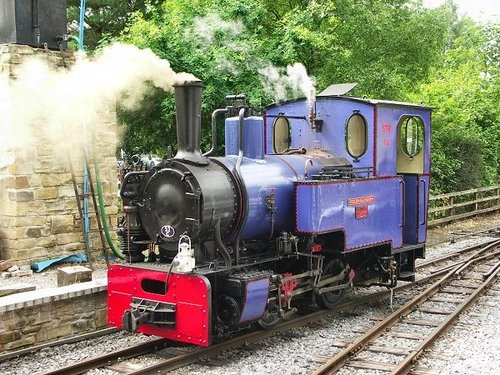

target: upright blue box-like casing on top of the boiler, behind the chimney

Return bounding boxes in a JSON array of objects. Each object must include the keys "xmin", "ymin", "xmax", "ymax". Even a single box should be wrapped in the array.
[{"xmin": 225, "ymin": 116, "xmax": 264, "ymax": 159}]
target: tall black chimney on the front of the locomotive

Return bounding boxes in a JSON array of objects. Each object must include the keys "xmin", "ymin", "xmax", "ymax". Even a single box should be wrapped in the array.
[{"xmin": 173, "ymin": 81, "xmax": 208, "ymax": 164}]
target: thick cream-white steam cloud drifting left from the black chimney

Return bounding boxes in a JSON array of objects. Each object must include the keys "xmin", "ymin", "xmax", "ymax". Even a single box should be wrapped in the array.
[{"xmin": 0, "ymin": 44, "xmax": 196, "ymax": 167}]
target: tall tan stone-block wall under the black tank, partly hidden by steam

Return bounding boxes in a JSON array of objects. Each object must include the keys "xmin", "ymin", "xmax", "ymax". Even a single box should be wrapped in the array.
[{"xmin": 0, "ymin": 45, "xmax": 118, "ymax": 264}]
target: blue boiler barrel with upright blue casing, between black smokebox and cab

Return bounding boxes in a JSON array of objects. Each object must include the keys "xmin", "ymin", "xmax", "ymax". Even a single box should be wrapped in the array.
[{"xmin": 221, "ymin": 116, "xmax": 321, "ymax": 240}]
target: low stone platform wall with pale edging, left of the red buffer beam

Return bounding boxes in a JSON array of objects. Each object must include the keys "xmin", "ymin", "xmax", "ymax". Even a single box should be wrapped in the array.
[{"xmin": 0, "ymin": 280, "xmax": 107, "ymax": 352}]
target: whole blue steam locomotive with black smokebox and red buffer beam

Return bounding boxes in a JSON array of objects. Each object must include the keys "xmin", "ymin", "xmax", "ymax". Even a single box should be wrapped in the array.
[{"xmin": 108, "ymin": 81, "xmax": 431, "ymax": 346}]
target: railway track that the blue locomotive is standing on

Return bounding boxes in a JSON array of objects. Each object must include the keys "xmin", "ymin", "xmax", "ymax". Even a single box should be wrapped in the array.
[{"xmin": 40, "ymin": 241, "xmax": 498, "ymax": 375}]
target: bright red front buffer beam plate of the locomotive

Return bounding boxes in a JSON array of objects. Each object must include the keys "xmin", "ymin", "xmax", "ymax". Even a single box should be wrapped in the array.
[{"xmin": 108, "ymin": 265, "xmax": 212, "ymax": 346}]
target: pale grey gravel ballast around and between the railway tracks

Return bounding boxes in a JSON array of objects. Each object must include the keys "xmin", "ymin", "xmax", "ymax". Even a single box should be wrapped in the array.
[{"xmin": 1, "ymin": 214, "xmax": 500, "ymax": 375}]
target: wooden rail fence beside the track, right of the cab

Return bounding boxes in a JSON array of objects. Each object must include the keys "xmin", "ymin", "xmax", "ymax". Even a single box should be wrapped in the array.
[{"xmin": 428, "ymin": 184, "xmax": 500, "ymax": 227}]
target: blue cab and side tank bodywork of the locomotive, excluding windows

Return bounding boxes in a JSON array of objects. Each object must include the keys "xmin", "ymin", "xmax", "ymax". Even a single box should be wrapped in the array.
[{"xmin": 265, "ymin": 96, "xmax": 431, "ymax": 249}]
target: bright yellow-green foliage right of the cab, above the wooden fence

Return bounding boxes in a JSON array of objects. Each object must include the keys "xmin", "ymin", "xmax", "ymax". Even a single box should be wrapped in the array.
[{"xmin": 410, "ymin": 19, "xmax": 500, "ymax": 192}]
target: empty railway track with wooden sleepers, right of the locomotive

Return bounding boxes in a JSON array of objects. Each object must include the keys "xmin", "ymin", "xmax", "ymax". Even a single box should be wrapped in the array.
[{"xmin": 314, "ymin": 240, "xmax": 500, "ymax": 375}]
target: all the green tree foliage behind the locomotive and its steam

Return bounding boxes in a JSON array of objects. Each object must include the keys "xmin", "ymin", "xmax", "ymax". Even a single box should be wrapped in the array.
[{"xmin": 69, "ymin": 0, "xmax": 500, "ymax": 192}]
